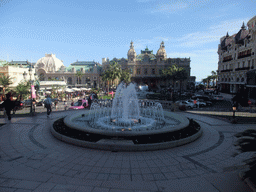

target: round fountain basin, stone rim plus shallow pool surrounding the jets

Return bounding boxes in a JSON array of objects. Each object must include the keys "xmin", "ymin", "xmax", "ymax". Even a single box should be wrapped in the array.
[{"xmin": 64, "ymin": 111, "xmax": 189, "ymax": 137}]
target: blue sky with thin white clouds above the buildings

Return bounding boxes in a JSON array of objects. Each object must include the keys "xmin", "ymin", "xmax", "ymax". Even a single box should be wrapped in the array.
[{"xmin": 0, "ymin": 0, "xmax": 256, "ymax": 81}]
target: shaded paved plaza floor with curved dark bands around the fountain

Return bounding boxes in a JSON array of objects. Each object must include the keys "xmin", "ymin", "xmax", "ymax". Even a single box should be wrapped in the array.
[{"xmin": 0, "ymin": 111, "xmax": 255, "ymax": 192}]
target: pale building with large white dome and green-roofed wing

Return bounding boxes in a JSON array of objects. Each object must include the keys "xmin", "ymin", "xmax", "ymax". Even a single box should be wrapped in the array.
[{"xmin": 35, "ymin": 54, "xmax": 101, "ymax": 88}]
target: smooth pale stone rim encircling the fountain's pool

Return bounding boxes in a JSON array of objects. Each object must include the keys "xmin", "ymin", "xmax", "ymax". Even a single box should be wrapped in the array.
[{"xmin": 64, "ymin": 110, "xmax": 189, "ymax": 137}]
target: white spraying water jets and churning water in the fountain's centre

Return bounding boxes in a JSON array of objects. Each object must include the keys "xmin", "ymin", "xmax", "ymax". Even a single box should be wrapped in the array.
[{"xmin": 81, "ymin": 83, "xmax": 180, "ymax": 132}]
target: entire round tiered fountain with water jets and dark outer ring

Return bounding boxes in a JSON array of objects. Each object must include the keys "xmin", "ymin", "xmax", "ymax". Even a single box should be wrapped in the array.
[{"xmin": 51, "ymin": 83, "xmax": 202, "ymax": 151}]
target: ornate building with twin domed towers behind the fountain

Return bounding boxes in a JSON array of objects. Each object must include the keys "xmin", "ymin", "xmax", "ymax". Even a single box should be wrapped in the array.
[{"xmin": 102, "ymin": 42, "xmax": 190, "ymax": 90}]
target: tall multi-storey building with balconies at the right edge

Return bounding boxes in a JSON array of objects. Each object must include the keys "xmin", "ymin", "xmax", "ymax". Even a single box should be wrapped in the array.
[{"xmin": 217, "ymin": 16, "xmax": 256, "ymax": 97}]
